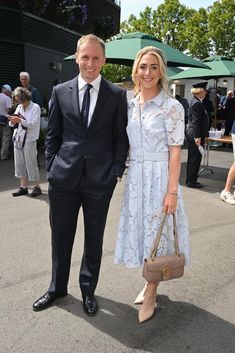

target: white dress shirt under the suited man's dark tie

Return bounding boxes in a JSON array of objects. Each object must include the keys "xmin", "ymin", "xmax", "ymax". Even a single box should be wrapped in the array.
[{"xmin": 78, "ymin": 74, "xmax": 101, "ymax": 126}]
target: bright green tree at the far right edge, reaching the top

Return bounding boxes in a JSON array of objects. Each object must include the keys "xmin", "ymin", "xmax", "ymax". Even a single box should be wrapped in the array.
[{"xmin": 208, "ymin": 0, "xmax": 235, "ymax": 58}]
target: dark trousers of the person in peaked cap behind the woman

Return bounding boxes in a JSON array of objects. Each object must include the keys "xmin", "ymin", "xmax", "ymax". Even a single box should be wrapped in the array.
[{"xmin": 186, "ymin": 134, "xmax": 202, "ymax": 184}]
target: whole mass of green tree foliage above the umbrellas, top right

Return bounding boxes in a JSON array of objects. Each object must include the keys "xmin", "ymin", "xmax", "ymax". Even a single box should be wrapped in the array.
[{"xmin": 121, "ymin": 0, "xmax": 235, "ymax": 60}]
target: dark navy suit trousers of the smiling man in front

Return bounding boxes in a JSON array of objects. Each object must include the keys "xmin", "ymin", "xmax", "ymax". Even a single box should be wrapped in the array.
[{"xmin": 48, "ymin": 165, "xmax": 116, "ymax": 296}]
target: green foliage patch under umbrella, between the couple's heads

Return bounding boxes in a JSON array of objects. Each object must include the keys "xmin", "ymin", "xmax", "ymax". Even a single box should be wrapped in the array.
[{"xmin": 102, "ymin": 64, "xmax": 131, "ymax": 82}]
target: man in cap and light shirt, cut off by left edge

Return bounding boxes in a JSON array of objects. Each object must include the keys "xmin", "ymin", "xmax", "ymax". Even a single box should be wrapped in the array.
[{"xmin": 0, "ymin": 84, "xmax": 12, "ymax": 160}]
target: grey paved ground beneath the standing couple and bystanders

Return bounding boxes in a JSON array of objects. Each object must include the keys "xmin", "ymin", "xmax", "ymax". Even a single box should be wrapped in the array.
[{"xmin": 0, "ymin": 150, "xmax": 235, "ymax": 353}]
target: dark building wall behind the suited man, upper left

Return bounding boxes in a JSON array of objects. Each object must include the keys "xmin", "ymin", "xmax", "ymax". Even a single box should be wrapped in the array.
[{"xmin": 0, "ymin": 6, "xmax": 81, "ymax": 104}]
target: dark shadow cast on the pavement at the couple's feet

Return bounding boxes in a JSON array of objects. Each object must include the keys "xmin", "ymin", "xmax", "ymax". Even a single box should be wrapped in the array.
[{"xmin": 57, "ymin": 295, "xmax": 235, "ymax": 353}]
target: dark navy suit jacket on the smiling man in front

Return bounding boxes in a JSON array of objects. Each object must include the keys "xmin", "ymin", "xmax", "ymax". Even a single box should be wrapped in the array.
[{"xmin": 46, "ymin": 77, "xmax": 128, "ymax": 190}]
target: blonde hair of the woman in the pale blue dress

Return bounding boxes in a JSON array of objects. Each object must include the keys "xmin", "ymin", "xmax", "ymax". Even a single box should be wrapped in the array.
[{"xmin": 132, "ymin": 46, "xmax": 169, "ymax": 95}]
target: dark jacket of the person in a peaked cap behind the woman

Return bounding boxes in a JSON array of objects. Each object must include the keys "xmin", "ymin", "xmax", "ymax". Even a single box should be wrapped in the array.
[{"xmin": 186, "ymin": 96, "xmax": 209, "ymax": 138}]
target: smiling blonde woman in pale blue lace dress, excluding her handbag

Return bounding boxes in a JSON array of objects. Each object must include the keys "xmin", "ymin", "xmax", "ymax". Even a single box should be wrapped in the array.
[{"xmin": 114, "ymin": 47, "xmax": 190, "ymax": 322}]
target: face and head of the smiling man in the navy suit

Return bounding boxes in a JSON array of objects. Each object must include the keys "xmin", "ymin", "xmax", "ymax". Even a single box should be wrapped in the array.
[{"xmin": 76, "ymin": 41, "xmax": 105, "ymax": 83}]
